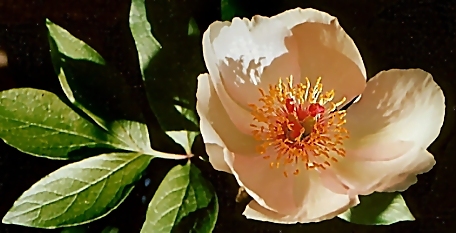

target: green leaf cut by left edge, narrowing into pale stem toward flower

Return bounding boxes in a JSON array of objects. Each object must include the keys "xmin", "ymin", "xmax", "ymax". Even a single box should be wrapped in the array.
[{"xmin": 0, "ymin": 88, "xmax": 188, "ymax": 159}]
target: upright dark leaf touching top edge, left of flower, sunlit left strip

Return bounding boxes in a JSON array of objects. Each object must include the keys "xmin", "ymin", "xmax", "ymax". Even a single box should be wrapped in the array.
[{"xmin": 130, "ymin": 0, "xmax": 203, "ymax": 131}]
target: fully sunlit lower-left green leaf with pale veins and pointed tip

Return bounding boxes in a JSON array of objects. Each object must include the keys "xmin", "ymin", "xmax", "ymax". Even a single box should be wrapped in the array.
[{"xmin": 2, "ymin": 153, "xmax": 152, "ymax": 229}]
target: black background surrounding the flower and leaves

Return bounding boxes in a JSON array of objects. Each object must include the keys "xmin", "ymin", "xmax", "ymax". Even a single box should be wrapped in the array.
[{"xmin": 0, "ymin": 0, "xmax": 456, "ymax": 233}]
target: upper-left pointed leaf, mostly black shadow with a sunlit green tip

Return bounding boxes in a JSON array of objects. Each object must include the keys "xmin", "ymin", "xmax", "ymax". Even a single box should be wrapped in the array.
[{"xmin": 46, "ymin": 20, "xmax": 142, "ymax": 126}]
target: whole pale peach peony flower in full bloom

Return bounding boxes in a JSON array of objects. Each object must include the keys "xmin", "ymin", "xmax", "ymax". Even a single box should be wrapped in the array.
[{"xmin": 197, "ymin": 8, "xmax": 445, "ymax": 223}]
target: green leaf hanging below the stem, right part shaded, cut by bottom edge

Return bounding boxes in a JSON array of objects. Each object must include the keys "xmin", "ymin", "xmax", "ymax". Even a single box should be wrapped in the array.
[{"xmin": 141, "ymin": 162, "xmax": 218, "ymax": 233}]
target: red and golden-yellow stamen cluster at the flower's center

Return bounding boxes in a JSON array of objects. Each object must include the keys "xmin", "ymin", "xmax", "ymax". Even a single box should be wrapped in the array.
[{"xmin": 249, "ymin": 76, "xmax": 348, "ymax": 176}]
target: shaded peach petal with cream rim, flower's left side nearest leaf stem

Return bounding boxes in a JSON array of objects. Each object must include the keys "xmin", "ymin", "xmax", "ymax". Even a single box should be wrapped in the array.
[{"xmin": 196, "ymin": 74, "xmax": 258, "ymax": 156}]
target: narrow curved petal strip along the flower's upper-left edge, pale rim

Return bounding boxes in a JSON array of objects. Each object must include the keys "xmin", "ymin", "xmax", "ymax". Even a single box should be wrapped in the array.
[{"xmin": 203, "ymin": 21, "xmax": 253, "ymax": 134}]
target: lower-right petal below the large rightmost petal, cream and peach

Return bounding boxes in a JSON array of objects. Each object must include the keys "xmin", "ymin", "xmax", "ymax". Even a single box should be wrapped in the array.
[{"xmin": 329, "ymin": 142, "xmax": 435, "ymax": 195}]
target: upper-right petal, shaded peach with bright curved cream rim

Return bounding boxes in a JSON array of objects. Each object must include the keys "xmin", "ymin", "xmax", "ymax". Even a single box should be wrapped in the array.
[{"xmin": 273, "ymin": 8, "xmax": 366, "ymax": 102}]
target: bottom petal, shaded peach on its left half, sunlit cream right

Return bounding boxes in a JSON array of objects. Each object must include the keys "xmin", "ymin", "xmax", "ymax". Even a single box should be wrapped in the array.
[{"xmin": 230, "ymin": 148, "xmax": 357, "ymax": 222}]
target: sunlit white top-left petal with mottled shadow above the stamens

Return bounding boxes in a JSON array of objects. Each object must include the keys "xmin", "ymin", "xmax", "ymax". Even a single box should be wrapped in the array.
[{"xmin": 212, "ymin": 16, "xmax": 300, "ymax": 108}]
